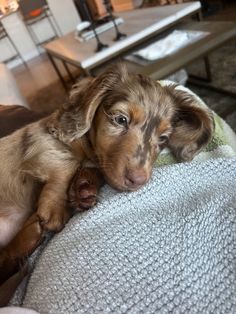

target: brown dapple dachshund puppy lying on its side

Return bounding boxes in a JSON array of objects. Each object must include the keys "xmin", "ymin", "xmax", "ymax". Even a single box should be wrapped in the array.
[{"xmin": 0, "ymin": 65, "xmax": 214, "ymax": 300}]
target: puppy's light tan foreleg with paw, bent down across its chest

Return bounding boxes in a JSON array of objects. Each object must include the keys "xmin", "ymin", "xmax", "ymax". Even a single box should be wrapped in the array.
[{"xmin": 37, "ymin": 169, "xmax": 75, "ymax": 232}]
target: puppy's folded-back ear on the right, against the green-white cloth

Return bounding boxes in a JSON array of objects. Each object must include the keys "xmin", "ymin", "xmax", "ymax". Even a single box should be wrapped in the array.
[{"xmin": 169, "ymin": 86, "xmax": 214, "ymax": 161}]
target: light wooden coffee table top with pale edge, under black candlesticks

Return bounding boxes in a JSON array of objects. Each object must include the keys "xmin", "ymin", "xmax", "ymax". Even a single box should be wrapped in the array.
[{"xmin": 44, "ymin": 1, "xmax": 200, "ymax": 85}]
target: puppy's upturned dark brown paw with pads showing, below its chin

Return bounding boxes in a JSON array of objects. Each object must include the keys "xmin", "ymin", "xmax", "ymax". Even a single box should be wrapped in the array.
[{"xmin": 69, "ymin": 178, "xmax": 98, "ymax": 211}]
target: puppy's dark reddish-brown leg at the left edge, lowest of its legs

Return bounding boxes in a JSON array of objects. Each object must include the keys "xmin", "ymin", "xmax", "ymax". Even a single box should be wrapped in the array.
[{"xmin": 0, "ymin": 213, "xmax": 44, "ymax": 285}]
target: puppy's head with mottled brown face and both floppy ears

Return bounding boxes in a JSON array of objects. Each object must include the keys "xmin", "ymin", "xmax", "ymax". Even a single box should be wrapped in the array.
[{"xmin": 55, "ymin": 65, "xmax": 212, "ymax": 190}]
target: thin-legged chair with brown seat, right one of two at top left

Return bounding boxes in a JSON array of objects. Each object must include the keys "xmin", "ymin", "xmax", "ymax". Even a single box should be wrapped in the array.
[{"xmin": 19, "ymin": 0, "xmax": 61, "ymax": 47}]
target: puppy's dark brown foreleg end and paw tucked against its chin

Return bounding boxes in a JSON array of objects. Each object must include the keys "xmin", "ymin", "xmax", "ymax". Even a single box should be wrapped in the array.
[{"xmin": 69, "ymin": 168, "xmax": 104, "ymax": 211}]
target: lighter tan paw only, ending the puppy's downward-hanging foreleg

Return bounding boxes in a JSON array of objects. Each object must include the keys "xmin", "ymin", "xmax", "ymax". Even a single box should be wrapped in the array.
[{"xmin": 37, "ymin": 208, "xmax": 71, "ymax": 232}]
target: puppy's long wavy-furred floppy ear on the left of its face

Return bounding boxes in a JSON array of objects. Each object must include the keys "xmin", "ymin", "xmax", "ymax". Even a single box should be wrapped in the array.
[{"xmin": 48, "ymin": 65, "xmax": 127, "ymax": 142}]
